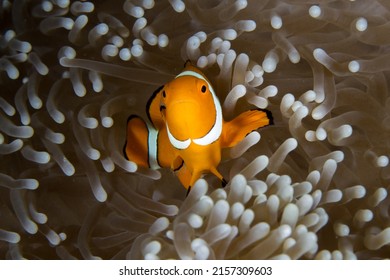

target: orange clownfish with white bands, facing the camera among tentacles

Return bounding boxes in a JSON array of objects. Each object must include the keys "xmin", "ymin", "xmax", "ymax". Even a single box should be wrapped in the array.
[{"xmin": 123, "ymin": 62, "xmax": 273, "ymax": 194}]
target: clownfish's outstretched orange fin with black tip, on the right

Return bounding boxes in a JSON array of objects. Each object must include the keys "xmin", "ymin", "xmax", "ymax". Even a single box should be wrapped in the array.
[{"xmin": 221, "ymin": 109, "xmax": 273, "ymax": 148}]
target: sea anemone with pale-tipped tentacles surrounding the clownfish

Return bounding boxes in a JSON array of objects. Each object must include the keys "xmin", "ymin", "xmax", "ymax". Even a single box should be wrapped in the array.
[{"xmin": 0, "ymin": 0, "xmax": 390, "ymax": 259}]
